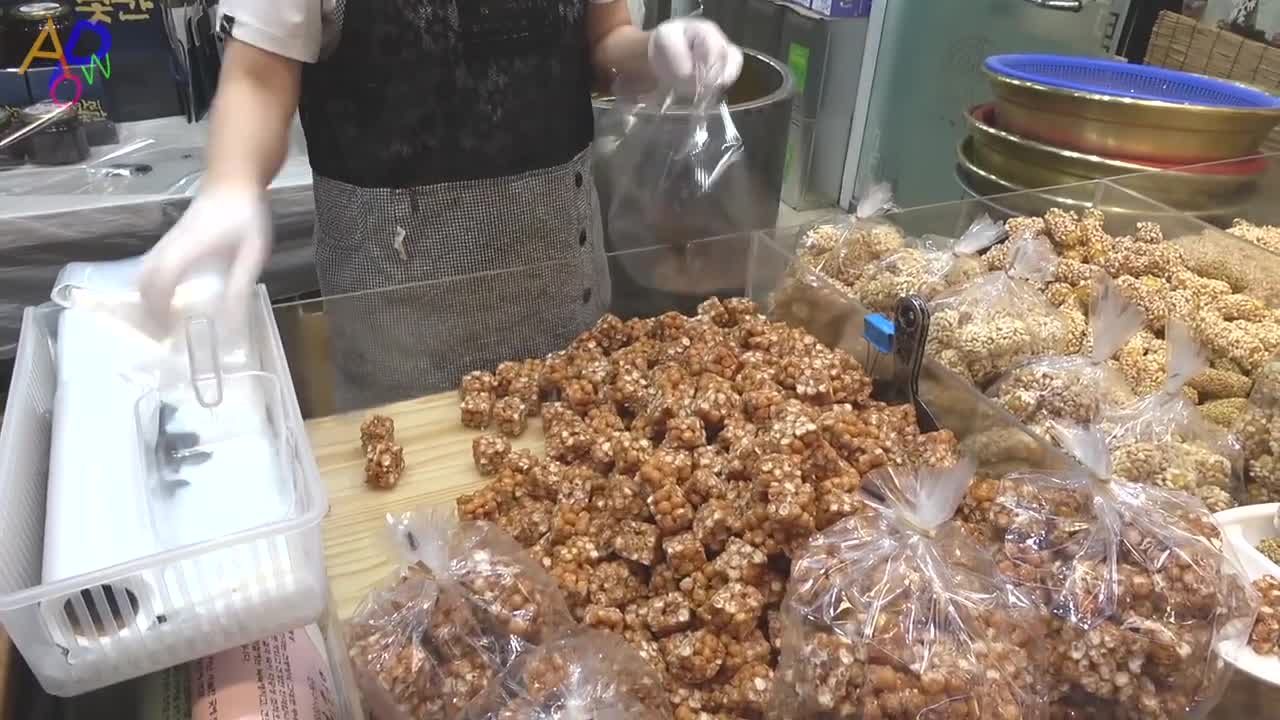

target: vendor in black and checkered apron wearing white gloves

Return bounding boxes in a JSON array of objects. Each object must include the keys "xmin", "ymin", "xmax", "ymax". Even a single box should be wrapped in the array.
[{"xmin": 142, "ymin": 0, "xmax": 742, "ymax": 409}]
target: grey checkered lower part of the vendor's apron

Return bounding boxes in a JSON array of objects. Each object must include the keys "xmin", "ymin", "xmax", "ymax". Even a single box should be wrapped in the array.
[{"xmin": 315, "ymin": 150, "xmax": 609, "ymax": 410}]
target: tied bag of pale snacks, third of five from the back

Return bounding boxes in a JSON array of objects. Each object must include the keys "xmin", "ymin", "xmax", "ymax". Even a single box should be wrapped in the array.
[{"xmin": 927, "ymin": 236, "xmax": 1069, "ymax": 387}]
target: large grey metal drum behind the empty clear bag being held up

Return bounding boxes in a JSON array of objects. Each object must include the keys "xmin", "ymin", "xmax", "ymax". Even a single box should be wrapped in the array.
[{"xmin": 594, "ymin": 49, "xmax": 795, "ymax": 316}]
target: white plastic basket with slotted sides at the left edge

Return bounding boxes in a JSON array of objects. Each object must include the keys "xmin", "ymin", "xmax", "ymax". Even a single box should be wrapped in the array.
[{"xmin": 0, "ymin": 287, "xmax": 328, "ymax": 697}]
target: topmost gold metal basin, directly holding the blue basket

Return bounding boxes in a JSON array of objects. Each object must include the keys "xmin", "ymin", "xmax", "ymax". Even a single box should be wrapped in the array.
[{"xmin": 983, "ymin": 69, "xmax": 1280, "ymax": 164}]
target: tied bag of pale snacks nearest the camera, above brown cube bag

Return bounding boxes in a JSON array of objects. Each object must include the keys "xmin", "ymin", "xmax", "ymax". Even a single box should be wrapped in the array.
[{"xmin": 1100, "ymin": 320, "xmax": 1244, "ymax": 512}]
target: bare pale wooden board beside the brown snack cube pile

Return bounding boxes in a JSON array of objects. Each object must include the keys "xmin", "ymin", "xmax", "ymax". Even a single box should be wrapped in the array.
[{"xmin": 307, "ymin": 392, "xmax": 543, "ymax": 618}]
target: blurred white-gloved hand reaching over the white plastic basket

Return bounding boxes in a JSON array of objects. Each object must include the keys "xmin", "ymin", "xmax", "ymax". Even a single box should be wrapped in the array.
[{"xmin": 138, "ymin": 190, "xmax": 271, "ymax": 333}]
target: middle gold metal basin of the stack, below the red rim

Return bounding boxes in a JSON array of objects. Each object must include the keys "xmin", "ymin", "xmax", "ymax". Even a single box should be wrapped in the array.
[{"xmin": 965, "ymin": 105, "xmax": 1267, "ymax": 211}]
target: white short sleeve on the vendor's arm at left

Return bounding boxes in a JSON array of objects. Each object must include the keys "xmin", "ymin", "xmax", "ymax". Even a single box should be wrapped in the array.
[{"xmin": 219, "ymin": 0, "xmax": 335, "ymax": 63}]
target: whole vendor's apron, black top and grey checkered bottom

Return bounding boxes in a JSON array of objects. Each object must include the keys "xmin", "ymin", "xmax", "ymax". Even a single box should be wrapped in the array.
[{"xmin": 301, "ymin": 0, "xmax": 609, "ymax": 409}]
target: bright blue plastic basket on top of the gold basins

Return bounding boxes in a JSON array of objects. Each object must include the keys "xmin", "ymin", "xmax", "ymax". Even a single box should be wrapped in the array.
[{"xmin": 986, "ymin": 55, "xmax": 1280, "ymax": 110}]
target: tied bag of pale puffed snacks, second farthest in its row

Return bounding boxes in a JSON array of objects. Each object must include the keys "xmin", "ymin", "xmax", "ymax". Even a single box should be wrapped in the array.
[{"xmin": 840, "ymin": 215, "xmax": 1005, "ymax": 313}]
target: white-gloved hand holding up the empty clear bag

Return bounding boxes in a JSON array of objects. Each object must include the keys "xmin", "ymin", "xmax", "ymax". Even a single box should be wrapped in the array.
[{"xmin": 649, "ymin": 18, "xmax": 742, "ymax": 94}]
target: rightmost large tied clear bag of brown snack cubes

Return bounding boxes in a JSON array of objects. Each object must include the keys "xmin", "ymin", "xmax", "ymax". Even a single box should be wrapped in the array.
[{"xmin": 987, "ymin": 427, "xmax": 1257, "ymax": 719}]
